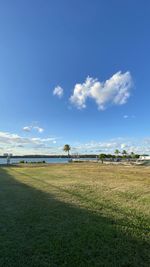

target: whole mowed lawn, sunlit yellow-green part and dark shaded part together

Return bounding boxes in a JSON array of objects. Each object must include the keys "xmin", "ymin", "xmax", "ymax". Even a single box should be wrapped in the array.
[{"xmin": 0, "ymin": 163, "xmax": 150, "ymax": 267}]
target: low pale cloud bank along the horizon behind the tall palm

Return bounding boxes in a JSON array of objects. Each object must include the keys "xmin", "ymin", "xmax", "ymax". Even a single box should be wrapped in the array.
[{"xmin": 0, "ymin": 131, "xmax": 150, "ymax": 155}]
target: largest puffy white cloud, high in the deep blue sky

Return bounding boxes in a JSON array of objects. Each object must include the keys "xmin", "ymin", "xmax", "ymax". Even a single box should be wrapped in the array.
[{"xmin": 70, "ymin": 71, "xmax": 133, "ymax": 110}]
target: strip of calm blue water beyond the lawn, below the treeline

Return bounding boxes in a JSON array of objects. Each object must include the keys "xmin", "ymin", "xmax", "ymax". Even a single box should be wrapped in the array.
[{"xmin": 0, "ymin": 158, "xmax": 95, "ymax": 164}]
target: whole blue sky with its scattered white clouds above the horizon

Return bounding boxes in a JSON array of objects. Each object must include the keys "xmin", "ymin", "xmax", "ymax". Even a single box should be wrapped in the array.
[{"xmin": 0, "ymin": 0, "xmax": 150, "ymax": 154}]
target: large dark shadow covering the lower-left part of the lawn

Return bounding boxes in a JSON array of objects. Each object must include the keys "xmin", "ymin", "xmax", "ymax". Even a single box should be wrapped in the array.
[{"xmin": 0, "ymin": 168, "xmax": 150, "ymax": 267}]
